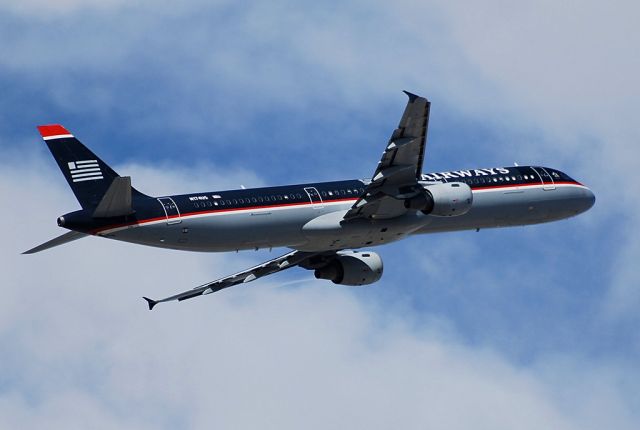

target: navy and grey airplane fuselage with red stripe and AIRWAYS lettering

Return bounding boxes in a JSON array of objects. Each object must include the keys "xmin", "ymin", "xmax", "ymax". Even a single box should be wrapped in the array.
[{"xmin": 58, "ymin": 166, "xmax": 595, "ymax": 252}]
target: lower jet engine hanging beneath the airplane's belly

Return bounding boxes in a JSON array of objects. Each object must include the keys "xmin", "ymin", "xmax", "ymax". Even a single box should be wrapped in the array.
[{"xmin": 315, "ymin": 251, "xmax": 383, "ymax": 286}]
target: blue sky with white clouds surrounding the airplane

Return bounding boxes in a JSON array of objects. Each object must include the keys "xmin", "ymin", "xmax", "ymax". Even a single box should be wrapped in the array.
[{"xmin": 0, "ymin": 0, "xmax": 640, "ymax": 429}]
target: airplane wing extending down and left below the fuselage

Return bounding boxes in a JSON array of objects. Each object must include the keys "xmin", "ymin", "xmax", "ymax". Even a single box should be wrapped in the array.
[{"xmin": 143, "ymin": 251, "xmax": 328, "ymax": 310}]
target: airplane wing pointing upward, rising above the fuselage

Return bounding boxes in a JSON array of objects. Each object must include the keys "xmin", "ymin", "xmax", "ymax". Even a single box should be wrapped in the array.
[{"xmin": 344, "ymin": 91, "xmax": 431, "ymax": 220}]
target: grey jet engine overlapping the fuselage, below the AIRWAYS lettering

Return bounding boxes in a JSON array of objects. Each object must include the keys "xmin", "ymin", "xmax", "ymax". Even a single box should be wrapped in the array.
[{"xmin": 404, "ymin": 182, "xmax": 473, "ymax": 216}]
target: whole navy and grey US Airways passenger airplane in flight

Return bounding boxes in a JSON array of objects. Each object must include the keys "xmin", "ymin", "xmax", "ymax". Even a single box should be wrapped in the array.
[{"xmin": 24, "ymin": 91, "xmax": 595, "ymax": 310}]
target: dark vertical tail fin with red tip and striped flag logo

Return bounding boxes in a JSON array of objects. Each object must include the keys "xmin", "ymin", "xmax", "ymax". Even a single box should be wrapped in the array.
[{"xmin": 38, "ymin": 124, "xmax": 144, "ymax": 210}]
